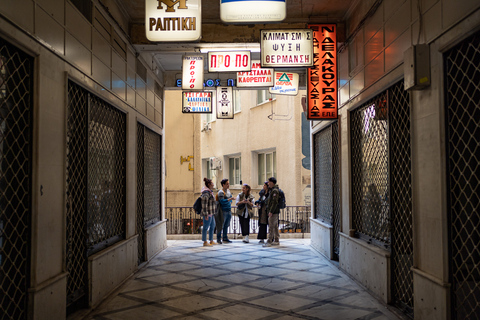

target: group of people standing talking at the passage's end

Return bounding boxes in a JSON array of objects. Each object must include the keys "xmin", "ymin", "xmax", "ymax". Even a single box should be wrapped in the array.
[{"xmin": 201, "ymin": 177, "xmax": 280, "ymax": 247}]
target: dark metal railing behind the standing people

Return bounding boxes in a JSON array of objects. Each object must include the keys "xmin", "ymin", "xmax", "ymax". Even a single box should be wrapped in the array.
[{"xmin": 165, "ymin": 206, "xmax": 310, "ymax": 235}]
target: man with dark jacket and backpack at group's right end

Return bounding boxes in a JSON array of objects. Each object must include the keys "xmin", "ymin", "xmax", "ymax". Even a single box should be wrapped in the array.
[{"xmin": 263, "ymin": 177, "xmax": 280, "ymax": 247}]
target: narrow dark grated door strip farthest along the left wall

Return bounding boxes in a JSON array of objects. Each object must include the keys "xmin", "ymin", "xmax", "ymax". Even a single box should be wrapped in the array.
[{"xmin": 137, "ymin": 123, "xmax": 145, "ymax": 264}]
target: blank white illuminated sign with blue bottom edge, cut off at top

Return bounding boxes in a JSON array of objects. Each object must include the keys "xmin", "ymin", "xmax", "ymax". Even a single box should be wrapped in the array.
[{"xmin": 220, "ymin": 0, "xmax": 287, "ymax": 23}]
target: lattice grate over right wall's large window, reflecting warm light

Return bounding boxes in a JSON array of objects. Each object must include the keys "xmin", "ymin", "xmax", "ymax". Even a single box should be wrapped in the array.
[{"xmin": 350, "ymin": 92, "xmax": 390, "ymax": 244}]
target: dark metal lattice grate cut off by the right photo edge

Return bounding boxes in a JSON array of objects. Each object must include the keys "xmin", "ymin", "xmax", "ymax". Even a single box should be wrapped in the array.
[{"xmin": 445, "ymin": 33, "xmax": 480, "ymax": 319}]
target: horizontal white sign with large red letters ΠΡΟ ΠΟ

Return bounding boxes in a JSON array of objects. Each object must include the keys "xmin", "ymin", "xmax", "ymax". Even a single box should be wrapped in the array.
[{"xmin": 208, "ymin": 51, "xmax": 251, "ymax": 72}]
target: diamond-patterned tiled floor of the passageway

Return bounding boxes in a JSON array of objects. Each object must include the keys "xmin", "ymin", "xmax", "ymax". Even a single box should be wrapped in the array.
[{"xmin": 86, "ymin": 239, "xmax": 399, "ymax": 320}]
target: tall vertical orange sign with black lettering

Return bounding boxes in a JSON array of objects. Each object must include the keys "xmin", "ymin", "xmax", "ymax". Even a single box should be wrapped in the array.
[{"xmin": 307, "ymin": 24, "xmax": 338, "ymax": 120}]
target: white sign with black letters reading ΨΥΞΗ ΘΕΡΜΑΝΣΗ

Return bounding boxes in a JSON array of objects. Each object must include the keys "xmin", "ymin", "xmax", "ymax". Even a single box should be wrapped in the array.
[{"xmin": 260, "ymin": 29, "xmax": 313, "ymax": 67}]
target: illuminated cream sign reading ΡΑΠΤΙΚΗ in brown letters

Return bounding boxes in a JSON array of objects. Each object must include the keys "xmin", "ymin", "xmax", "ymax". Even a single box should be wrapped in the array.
[{"xmin": 145, "ymin": 0, "xmax": 202, "ymax": 41}]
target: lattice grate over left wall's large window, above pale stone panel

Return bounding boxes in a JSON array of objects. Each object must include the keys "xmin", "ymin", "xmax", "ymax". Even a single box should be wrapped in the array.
[{"xmin": 87, "ymin": 95, "xmax": 126, "ymax": 255}]
